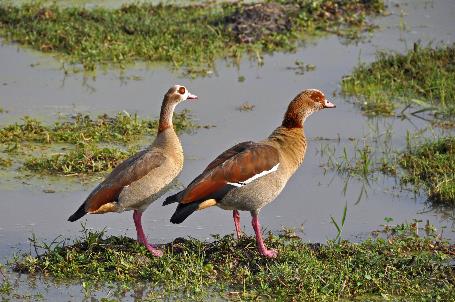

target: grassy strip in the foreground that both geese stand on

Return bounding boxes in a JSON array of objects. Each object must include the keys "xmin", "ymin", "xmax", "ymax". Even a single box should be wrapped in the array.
[{"xmin": 9, "ymin": 230, "xmax": 455, "ymax": 301}]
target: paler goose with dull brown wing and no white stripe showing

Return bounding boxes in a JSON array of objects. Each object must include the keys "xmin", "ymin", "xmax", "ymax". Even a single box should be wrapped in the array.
[{"xmin": 68, "ymin": 85, "xmax": 197, "ymax": 256}]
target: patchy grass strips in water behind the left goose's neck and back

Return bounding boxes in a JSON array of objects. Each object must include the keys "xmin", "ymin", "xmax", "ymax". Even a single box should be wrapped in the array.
[{"xmin": 0, "ymin": 110, "xmax": 200, "ymax": 175}]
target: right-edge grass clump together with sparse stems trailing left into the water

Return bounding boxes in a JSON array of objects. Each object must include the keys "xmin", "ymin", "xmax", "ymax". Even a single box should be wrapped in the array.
[{"xmin": 319, "ymin": 136, "xmax": 455, "ymax": 204}]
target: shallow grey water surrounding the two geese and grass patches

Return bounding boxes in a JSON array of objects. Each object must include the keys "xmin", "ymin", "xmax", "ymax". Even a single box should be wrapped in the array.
[{"xmin": 0, "ymin": 0, "xmax": 455, "ymax": 299}]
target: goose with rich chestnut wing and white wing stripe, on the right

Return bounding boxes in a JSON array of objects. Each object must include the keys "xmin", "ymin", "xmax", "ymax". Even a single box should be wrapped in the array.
[{"xmin": 163, "ymin": 89, "xmax": 335, "ymax": 258}]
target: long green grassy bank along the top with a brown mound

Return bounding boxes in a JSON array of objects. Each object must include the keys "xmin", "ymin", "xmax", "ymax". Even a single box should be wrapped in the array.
[{"xmin": 0, "ymin": 0, "xmax": 384, "ymax": 73}]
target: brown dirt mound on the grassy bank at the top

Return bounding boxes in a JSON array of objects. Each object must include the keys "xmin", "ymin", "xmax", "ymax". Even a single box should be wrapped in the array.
[{"xmin": 225, "ymin": 3, "xmax": 292, "ymax": 43}]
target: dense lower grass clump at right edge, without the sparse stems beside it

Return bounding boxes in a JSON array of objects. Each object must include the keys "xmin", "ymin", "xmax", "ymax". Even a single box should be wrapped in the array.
[{"xmin": 400, "ymin": 137, "xmax": 455, "ymax": 204}]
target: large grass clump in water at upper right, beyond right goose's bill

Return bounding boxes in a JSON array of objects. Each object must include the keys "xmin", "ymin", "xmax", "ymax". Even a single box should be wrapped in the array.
[{"xmin": 342, "ymin": 44, "xmax": 455, "ymax": 119}]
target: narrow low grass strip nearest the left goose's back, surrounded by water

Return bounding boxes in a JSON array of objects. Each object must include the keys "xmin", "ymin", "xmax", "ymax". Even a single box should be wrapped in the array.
[{"xmin": 24, "ymin": 144, "xmax": 133, "ymax": 175}]
